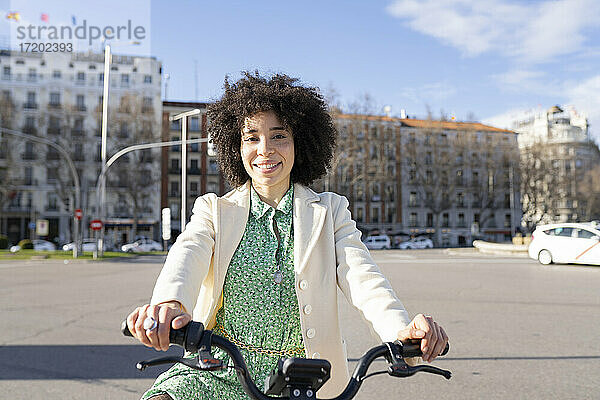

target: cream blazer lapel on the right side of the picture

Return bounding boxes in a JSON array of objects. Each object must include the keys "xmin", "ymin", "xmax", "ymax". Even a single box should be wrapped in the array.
[{"xmin": 293, "ymin": 184, "xmax": 327, "ymax": 273}]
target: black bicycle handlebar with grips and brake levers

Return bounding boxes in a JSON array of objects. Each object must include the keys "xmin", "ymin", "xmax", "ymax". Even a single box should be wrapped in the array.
[{"xmin": 121, "ymin": 321, "xmax": 452, "ymax": 400}]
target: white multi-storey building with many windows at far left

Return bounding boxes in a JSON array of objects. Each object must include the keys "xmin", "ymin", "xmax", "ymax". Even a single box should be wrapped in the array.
[{"xmin": 0, "ymin": 50, "xmax": 162, "ymax": 247}]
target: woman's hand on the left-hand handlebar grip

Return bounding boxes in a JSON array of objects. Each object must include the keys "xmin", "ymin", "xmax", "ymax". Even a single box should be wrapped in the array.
[{"xmin": 127, "ymin": 301, "xmax": 192, "ymax": 351}]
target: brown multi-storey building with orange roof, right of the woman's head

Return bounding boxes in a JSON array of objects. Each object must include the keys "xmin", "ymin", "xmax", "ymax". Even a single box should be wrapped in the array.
[{"xmin": 315, "ymin": 114, "xmax": 521, "ymax": 246}]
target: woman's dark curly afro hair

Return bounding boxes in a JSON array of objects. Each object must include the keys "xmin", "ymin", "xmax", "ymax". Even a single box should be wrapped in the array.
[{"xmin": 207, "ymin": 71, "xmax": 337, "ymax": 187}]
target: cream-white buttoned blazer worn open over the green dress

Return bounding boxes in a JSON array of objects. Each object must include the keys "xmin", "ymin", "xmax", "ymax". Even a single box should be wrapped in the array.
[{"xmin": 151, "ymin": 181, "xmax": 410, "ymax": 397}]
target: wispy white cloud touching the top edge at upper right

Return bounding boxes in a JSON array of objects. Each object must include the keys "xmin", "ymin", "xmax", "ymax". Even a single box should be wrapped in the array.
[{"xmin": 386, "ymin": 0, "xmax": 600, "ymax": 63}]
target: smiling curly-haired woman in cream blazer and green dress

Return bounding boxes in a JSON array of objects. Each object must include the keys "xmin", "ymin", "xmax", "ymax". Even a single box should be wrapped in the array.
[{"xmin": 127, "ymin": 73, "xmax": 448, "ymax": 400}]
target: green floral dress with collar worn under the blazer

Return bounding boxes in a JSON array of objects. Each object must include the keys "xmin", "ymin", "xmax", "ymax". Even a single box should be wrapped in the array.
[{"xmin": 142, "ymin": 185, "xmax": 305, "ymax": 400}]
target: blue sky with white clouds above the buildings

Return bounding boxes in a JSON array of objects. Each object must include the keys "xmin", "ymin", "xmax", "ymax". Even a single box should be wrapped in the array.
[{"xmin": 0, "ymin": 0, "xmax": 600, "ymax": 138}]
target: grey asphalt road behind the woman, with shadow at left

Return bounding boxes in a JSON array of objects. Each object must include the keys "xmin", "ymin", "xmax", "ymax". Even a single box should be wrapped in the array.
[{"xmin": 0, "ymin": 250, "xmax": 600, "ymax": 400}]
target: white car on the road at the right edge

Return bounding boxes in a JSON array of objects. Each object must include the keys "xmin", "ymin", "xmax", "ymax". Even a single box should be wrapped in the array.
[{"xmin": 528, "ymin": 223, "xmax": 600, "ymax": 265}]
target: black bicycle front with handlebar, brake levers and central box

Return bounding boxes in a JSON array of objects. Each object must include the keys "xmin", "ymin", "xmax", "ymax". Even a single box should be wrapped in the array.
[{"xmin": 121, "ymin": 321, "xmax": 452, "ymax": 400}]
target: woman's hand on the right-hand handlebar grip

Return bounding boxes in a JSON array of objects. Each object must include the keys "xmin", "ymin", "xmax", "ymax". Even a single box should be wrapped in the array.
[{"xmin": 398, "ymin": 314, "xmax": 448, "ymax": 362}]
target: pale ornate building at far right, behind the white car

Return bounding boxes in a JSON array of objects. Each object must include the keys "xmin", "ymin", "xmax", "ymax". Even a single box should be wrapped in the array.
[{"xmin": 513, "ymin": 106, "xmax": 600, "ymax": 229}]
